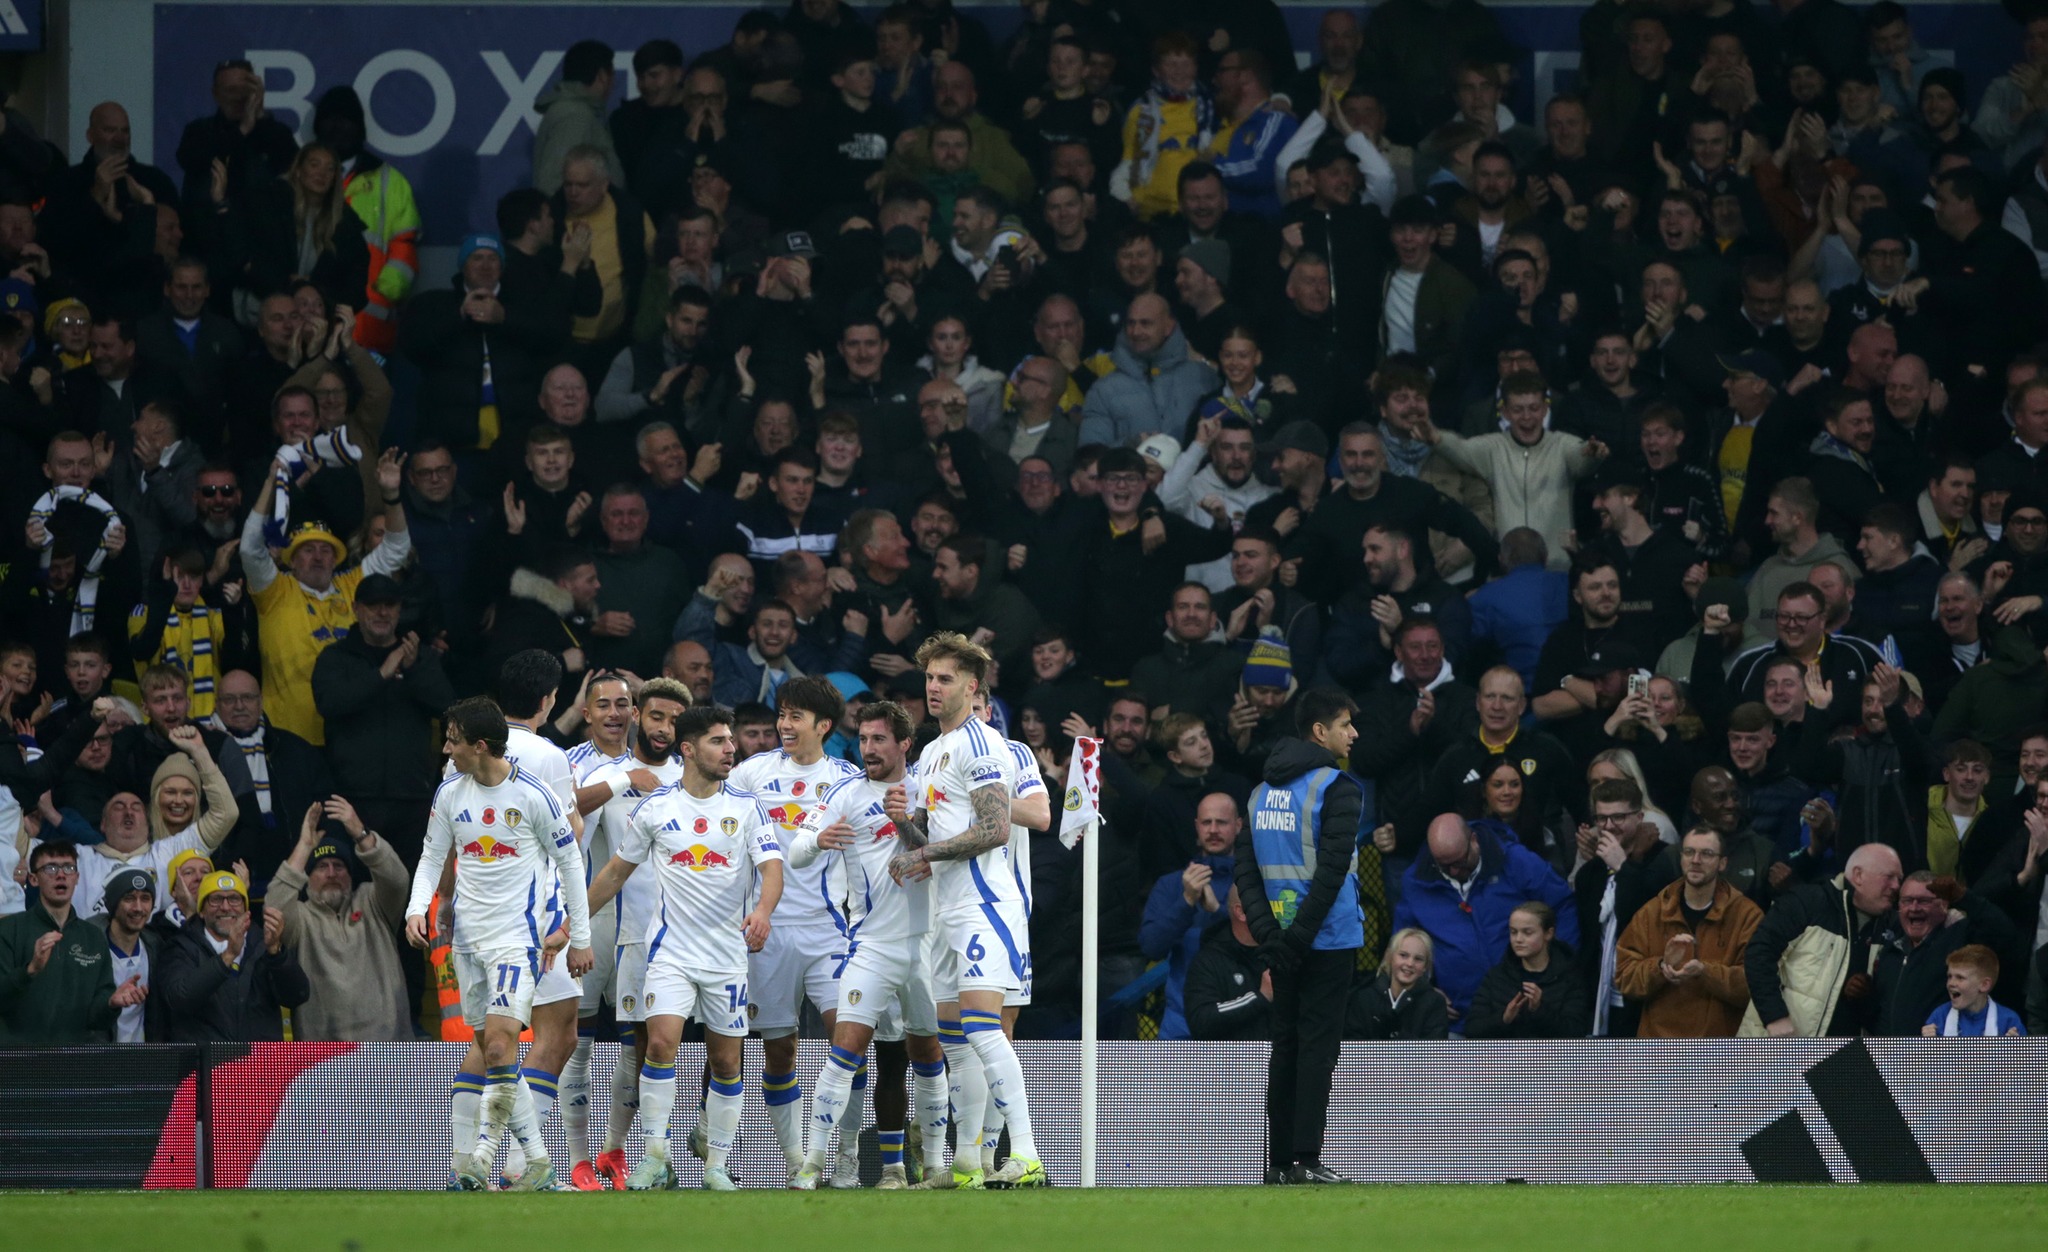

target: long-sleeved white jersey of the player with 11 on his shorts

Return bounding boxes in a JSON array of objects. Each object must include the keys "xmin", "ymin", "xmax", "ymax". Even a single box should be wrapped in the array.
[{"xmin": 406, "ymin": 768, "xmax": 590, "ymax": 953}]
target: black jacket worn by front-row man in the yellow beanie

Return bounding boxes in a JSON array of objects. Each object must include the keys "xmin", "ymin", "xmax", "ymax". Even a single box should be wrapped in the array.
[{"xmin": 150, "ymin": 914, "xmax": 313, "ymax": 1043}]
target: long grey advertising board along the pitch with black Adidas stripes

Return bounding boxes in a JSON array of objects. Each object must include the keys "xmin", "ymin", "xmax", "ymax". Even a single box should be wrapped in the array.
[{"xmin": 0, "ymin": 1039, "xmax": 2048, "ymax": 1188}]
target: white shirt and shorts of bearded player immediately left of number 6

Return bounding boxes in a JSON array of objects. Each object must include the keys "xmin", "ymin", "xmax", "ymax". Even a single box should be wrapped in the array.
[{"xmin": 788, "ymin": 775, "xmax": 938, "ymax": 1039}]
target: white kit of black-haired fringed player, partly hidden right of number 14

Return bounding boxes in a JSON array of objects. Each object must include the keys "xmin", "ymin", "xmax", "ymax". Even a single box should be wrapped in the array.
[{"xmin": 731, "ymin": 748, "xmax": 862, "ymax": 1039}]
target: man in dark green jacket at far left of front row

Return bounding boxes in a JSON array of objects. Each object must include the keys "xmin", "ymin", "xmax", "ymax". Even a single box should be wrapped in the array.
[{"xmin": 0, "ymin": 840, "xmax": 147, "ymax": 1047}]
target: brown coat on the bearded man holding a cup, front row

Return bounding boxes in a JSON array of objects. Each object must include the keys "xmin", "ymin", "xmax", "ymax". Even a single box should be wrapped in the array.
[{"xmin": 1614, "ymin": 879, "xmax": 1763, "ymax": 1039}]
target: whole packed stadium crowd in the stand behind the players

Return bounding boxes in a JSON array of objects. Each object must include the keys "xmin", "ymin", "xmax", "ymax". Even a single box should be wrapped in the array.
[{"xmin": 0, "ymin": 0, "xmax": 2048, "ymax": 1057}]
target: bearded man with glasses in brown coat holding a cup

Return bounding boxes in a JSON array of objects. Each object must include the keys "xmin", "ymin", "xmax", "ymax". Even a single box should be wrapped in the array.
[{"xmin": 1614, "ymin": 826, "xmax": 1763, "ymax": 1039}]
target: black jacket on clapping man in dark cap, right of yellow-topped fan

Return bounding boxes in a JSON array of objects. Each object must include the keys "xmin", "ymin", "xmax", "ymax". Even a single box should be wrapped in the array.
[{"xmin": 313, "ymin": 631, "xmax": 455, "ymax": 799}]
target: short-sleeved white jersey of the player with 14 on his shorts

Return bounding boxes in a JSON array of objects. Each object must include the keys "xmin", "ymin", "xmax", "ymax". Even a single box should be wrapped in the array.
[{"xmin": 616, "ymin": 783, "xmax": 786, "ymax": 982}]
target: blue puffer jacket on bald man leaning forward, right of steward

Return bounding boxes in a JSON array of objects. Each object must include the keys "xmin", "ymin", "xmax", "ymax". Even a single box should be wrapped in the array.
[{"xmin": 1395, "ymin": 826, "xmax": 1579, "ymax": 1016}]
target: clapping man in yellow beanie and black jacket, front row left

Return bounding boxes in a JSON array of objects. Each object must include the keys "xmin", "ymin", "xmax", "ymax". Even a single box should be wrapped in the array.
[{"xmin": 158, "ymin": 871, "xmax": 311, "ymax": 1043}]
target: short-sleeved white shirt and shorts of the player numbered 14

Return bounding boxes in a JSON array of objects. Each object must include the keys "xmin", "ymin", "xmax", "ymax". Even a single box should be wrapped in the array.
[{"xmin": 614, "ymin": 783, "xmax": 782, "ymax": 1037}]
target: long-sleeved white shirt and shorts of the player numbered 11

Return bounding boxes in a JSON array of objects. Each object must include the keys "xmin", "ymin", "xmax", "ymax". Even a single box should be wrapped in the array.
[{"xmin": 406, "ymin": 768, "xmax": 590, "ymax": 1031}]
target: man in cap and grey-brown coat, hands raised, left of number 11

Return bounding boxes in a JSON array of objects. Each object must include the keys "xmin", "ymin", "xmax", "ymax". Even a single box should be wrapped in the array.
[{"xmin": 264, "ymin": 795, "xmax": 412, "ymax": 1043}]
